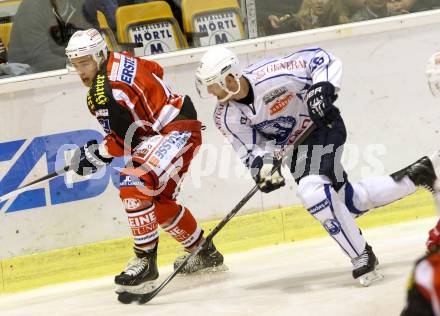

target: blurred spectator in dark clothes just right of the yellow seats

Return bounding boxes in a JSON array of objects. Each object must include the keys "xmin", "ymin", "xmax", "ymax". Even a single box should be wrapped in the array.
[{"xmin": 255, "ymin": 0, "xmax": 302, "ymax": 36}]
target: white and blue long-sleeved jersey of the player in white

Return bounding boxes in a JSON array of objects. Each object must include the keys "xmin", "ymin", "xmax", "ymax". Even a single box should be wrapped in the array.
[{"xmin": 214, "ymin": 48, "xmax": 342, "ymax": 167}]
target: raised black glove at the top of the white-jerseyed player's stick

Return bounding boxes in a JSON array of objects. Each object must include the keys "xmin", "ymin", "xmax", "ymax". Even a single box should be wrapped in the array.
[{"xmin": 304, "ymin": 81, "xmax": 339, "ymax": 127}]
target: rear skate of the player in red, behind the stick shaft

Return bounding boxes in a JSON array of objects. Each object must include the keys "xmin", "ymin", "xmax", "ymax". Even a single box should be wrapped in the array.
[{"xmin": 174, "ymin": 241, "xmax": 228, "ymax": 275}]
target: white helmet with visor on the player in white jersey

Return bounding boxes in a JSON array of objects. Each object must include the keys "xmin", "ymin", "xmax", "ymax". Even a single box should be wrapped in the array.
[{"xmin": 196, "ymin": 46, "xmax": 242, "ymax": 102}]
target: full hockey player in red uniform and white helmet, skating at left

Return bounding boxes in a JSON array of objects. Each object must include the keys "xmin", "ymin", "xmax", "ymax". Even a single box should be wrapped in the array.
[{"xmin": 66, "ymin": 29, "xmax": 223, "ymax": 293}]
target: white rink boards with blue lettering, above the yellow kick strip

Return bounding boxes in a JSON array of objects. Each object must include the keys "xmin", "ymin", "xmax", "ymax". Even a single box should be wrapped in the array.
[{"xmin": 0, "ymin": 11, "xmax": 440, "ymax": 259}]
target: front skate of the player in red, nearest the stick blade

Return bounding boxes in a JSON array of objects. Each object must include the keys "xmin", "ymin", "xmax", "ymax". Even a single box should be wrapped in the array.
[{"xmin": 115, "ymin": 249, "xmax": 159, "ymax": 294}]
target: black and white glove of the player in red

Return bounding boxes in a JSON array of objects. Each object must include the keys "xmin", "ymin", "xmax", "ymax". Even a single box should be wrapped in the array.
[{"xmin": 72, "ymin": 140, "xmax": 113, "ymax": 176}]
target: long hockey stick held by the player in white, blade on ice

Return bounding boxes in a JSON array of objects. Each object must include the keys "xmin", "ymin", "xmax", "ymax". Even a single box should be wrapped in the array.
[{"xmin": 118, "ymin": 125, "xmax": 316, "ymax": 304}]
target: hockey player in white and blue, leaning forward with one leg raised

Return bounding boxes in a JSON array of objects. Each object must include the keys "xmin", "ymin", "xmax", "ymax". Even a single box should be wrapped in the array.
[{"xmin": 196, "ymin": 46, "xmax": 436, "ymax": 286}]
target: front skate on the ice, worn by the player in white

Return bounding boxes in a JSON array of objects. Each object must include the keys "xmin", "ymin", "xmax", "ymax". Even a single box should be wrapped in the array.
[{"xmin": 351, "ymin": 244, "xmax": 383, "ymax": 286}]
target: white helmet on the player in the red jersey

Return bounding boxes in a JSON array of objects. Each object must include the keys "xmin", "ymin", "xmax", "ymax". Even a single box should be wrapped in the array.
[{"xmin": 66, "ymin": 29, "xmax": 108, "ymax": 67}]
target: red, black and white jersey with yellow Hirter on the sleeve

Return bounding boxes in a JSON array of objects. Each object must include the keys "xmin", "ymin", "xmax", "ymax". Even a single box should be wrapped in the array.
[{"xmin": 87, "ymin": 52, "xmax": 184, "ymax": 156}]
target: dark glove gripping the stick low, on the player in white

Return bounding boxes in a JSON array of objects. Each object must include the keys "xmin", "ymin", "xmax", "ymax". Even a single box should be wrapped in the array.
[{"xmin": 251, "ymin": 157, "xmax": 286, "ymax": 193}]
